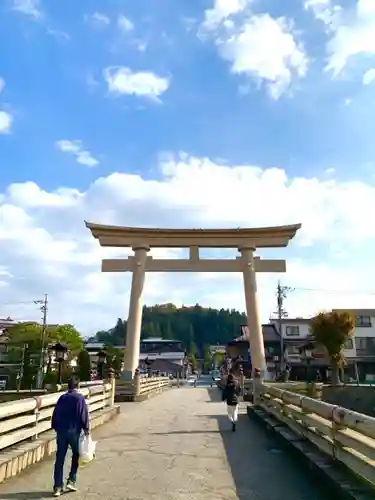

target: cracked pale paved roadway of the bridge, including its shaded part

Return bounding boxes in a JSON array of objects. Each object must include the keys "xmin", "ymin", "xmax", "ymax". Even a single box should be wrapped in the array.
[{"xmin": 0, "ymin": 388, "xmax": 325, "ymax": 500}]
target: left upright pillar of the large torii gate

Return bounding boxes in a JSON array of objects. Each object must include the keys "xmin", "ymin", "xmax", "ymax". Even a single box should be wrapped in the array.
[{"xmin": 123, "ymin": 245, "xmax": 150, "ymax": 380}]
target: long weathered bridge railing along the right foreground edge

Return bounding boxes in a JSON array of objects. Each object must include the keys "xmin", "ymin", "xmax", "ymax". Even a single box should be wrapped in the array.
[{"xmin": 257, "ymin": 383, "xmax": 375, "ymax": 483}]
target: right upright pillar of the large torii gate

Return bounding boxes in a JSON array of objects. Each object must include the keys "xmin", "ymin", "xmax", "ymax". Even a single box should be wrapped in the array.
[{"xmin": 239, "ymin": 248, "xmax": 268, "ymax": 379}]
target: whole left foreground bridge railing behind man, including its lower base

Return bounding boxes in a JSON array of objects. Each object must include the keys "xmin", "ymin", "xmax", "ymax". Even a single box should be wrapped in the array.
[{"xmin": 0, "ymin": 380, "xmax": 119, "ymax": 483}]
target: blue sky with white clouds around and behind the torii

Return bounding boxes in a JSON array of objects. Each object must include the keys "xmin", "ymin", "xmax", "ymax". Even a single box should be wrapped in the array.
[{"xmin": 0, "ymin": 0, "xmax": 375, "ymax": 335}]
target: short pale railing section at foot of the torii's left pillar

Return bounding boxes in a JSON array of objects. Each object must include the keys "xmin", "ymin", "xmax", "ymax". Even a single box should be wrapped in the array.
[{"xmin": 116, "ymin": 374, "xmax": 172, "ymax": 402}]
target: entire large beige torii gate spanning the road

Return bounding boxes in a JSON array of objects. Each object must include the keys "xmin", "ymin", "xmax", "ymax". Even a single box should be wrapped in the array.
[{"xmin": 85, "ymin": 222, "xmax": 301, "ymax": 379}]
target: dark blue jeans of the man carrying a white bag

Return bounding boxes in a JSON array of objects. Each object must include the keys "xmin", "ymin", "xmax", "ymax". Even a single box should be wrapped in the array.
[{"xmin": 54, "ymin": 431, "xmax": 80, "ymax": 488}]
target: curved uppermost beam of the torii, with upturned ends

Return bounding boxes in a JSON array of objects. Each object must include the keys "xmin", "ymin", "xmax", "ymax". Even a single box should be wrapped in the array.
[{"xmin": 85, "ymin": 221, "xmax": 301, "ymax": 248}]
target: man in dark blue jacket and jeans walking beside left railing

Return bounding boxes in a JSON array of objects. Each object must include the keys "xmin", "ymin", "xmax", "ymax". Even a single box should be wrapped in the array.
[{"xmin": 52, "ymin": 377, "xmax": 90, "ymax": 497}]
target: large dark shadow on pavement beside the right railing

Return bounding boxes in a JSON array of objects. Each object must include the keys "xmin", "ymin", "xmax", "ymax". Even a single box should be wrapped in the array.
[{"xmin": 206, "ymin": 415, "xmax": 329, "ymax": 500}]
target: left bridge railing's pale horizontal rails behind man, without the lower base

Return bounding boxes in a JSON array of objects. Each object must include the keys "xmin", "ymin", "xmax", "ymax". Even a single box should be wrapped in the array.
[{"xmin": 0, "ymin": 381, "xmax": 115, "ymax": 451}]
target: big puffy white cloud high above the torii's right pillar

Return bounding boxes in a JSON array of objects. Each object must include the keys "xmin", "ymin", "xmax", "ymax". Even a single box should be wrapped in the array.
[{"xmin": 200, "ymin": 0, "xmax": 308, "ymax": 99}]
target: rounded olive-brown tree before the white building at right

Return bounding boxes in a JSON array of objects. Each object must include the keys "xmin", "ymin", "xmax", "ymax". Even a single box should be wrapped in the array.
[{"xmin": 310, "ymin": 311, "xmax": 355, "ymax": 385}]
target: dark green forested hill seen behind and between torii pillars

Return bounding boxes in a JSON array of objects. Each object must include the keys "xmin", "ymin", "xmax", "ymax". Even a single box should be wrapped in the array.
[{"xmin": 90, "ymin": 304, "xmax": 246, "ymax": 355}]
